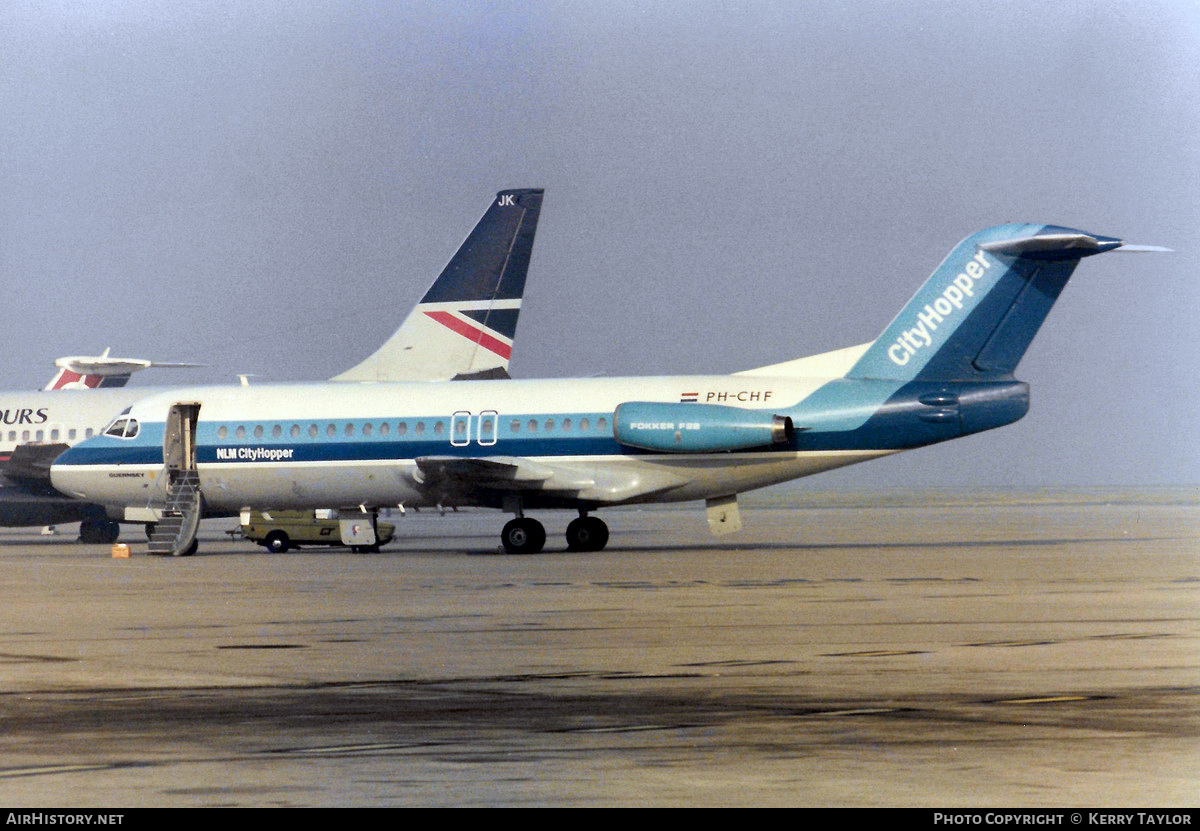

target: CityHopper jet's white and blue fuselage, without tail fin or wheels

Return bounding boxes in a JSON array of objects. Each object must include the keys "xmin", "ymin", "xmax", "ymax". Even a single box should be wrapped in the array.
[{"xmin": 53, "ymin": 375, "xmax": 1028, "ymax": 510}]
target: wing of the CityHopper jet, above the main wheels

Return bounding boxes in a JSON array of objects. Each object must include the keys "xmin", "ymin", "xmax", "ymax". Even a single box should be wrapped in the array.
[{"xmin": 415, "ymin": 456, "xmax": 686, "ymax": 504}]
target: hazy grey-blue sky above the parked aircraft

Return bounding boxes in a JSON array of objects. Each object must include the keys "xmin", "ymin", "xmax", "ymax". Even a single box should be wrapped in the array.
[{"xmin": 0, "ymin": 0, "xmax": 1200, "ymax": 486}]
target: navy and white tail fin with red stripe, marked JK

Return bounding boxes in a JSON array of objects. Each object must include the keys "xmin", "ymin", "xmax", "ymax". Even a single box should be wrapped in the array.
[{"xmin": 332, "ymin": 189, "xmax": 542, "ymax": 382}]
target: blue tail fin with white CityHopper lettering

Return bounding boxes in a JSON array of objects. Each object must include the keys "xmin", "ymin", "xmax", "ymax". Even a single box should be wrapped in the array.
[{"xmin": 846, "ymin": 225, "xmax": 1165, "ymax": 381}]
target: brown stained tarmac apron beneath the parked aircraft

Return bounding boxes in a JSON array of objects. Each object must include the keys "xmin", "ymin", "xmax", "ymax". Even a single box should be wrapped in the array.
[{"xmin": 0, "ymin": 489, "xmax": 1200, "ymax": 808}]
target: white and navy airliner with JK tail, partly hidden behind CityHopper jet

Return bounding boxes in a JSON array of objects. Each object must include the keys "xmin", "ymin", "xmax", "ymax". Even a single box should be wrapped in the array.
[{"xmin": 7, "ymin": 189, "xmax": 542, "ymax": 542}]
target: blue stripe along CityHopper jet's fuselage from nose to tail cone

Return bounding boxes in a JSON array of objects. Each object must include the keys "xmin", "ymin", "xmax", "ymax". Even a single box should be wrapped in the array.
[{"xmin": 58, "ymin": 382, "xmax": 1028, "ymax": 465}]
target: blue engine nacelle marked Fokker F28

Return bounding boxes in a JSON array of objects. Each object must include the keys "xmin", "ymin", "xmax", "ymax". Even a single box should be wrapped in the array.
[{"xmin": 612, "ymin": 401, "xmax": 793, "ymax": 453}]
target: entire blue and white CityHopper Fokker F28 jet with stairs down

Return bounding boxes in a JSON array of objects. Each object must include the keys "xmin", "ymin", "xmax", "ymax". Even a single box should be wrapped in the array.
[{"xmin": 52, "ymin": 225, "xmax": 1151, "ymax": 554}]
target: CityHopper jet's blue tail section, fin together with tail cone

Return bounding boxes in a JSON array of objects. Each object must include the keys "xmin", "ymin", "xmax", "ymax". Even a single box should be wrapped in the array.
[{"xmin": 772, "ymin": 225, "xmax": 1166, "ymax": 450}]
